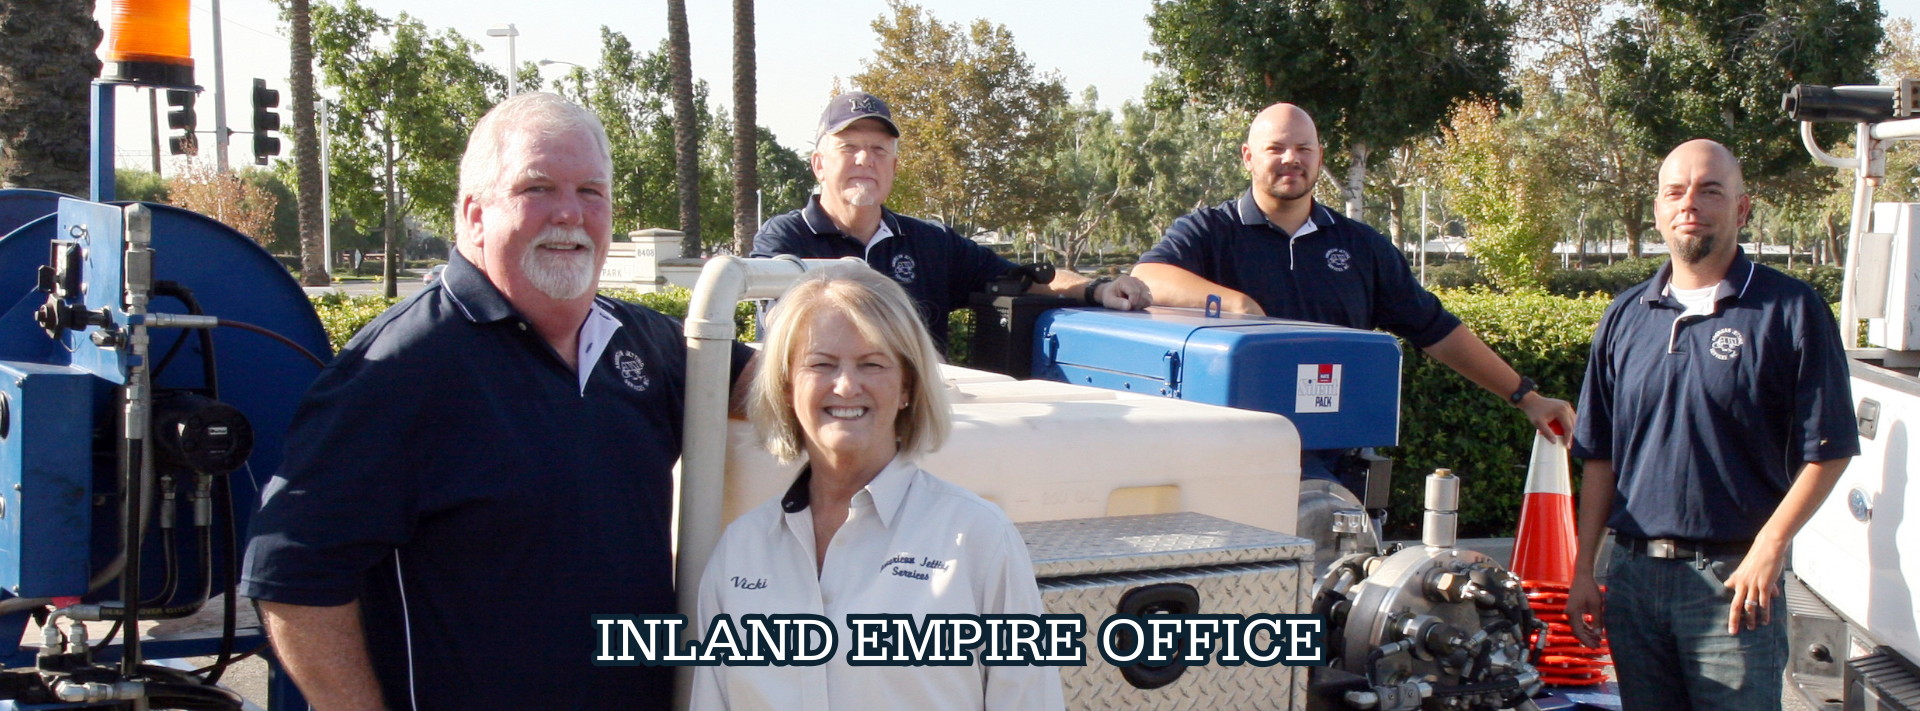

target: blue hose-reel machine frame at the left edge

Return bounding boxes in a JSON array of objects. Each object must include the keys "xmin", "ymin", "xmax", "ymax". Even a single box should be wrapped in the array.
[{"xmin": 0, "ymin": 190, "xmax": 332, "ymax": 707}]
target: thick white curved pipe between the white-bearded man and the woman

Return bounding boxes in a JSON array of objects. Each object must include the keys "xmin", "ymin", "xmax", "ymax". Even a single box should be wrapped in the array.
[{"xmin": 674, "ymin": 256, "xmax": 860, "ymax": 709}]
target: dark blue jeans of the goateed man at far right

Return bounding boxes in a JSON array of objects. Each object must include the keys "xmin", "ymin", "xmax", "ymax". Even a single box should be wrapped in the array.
[{"xmin": 1605, "ymin": 546, "xmax": 1788, "ymax": 711}]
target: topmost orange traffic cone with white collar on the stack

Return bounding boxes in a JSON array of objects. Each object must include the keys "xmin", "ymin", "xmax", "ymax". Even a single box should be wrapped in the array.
[{"xmin": 1513, "ymin": 434, "xmax": 1580, "ymax": 586}]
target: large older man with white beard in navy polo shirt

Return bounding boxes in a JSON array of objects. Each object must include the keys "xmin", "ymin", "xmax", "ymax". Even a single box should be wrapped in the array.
[{"xmin": 240, "ymin": 92, "xmax": 751, "ymax": 709}]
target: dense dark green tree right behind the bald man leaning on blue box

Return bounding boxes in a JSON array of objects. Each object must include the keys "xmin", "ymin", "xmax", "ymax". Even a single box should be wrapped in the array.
[{"xmin": 1148, "ymin": 0, "xmax": 1513, "ymax": 219}]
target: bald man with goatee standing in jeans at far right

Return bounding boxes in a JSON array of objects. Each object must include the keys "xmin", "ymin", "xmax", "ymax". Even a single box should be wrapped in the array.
[{"xmin": 1567, "ymin": 140, "xmax": 1860, "ymax": 711}]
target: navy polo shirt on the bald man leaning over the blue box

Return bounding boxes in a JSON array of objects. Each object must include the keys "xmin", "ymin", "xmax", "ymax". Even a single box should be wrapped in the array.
[{"xmin": 1140, "ymin": 190, "xmax": 1459, "ymax": 348}]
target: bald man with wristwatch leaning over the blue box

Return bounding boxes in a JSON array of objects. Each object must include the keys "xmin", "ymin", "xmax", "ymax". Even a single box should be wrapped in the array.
[{"xmin": 1133, "ymin": 104, "xmax": 1574, "ymax": 488}]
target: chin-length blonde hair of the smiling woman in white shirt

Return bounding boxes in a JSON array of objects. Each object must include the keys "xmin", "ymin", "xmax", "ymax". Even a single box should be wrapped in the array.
[{"xmin": 747, "ymin": 263, "xmax": 952, "ymax": 463}]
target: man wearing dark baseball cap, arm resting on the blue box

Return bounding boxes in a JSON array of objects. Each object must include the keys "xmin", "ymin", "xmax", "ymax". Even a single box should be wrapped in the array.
[{"xmin": 753, "ymin": 92, "xmax": 1152, "ymax": 350}]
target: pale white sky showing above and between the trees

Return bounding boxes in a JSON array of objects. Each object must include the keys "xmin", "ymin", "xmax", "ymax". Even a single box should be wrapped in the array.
[{"xmin": 98, "ymin": 0, "xmax": 1920, "ymax": 169}]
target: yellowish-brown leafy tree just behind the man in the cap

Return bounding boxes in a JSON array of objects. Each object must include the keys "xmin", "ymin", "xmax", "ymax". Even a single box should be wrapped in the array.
[{"xmin": 852, "ymin": 0, "xmax": 1068, "ymax": 234}]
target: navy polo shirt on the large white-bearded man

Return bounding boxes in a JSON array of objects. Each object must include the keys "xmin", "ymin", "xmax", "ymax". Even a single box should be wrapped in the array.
[{"xmin": 240, "ymin": 247, "xmax": 745, "ymax": 709}]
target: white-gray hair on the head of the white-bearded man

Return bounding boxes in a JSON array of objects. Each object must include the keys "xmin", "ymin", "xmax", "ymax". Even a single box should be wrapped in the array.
[{"xmin": 453, "ymin": 92, "xmax": 612, "ymax": 234}]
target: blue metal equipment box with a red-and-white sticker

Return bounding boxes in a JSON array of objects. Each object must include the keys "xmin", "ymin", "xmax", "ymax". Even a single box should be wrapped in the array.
[{"xmin": 1033, "ymin": 307, "xmax": 1400, "ymax": 450}]
